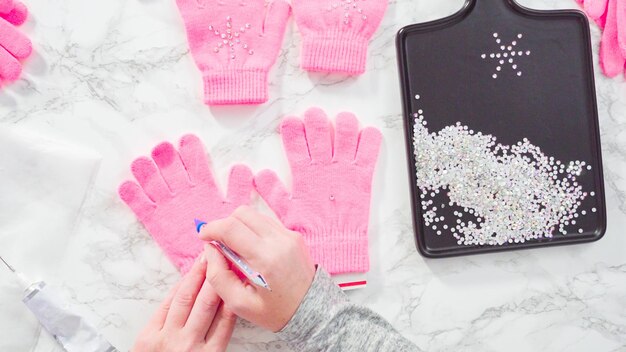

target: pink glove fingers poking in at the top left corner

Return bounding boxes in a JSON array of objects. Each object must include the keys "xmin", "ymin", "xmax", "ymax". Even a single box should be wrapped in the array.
[{"xmin": 0, "ymin": 0, "xmax": 33, "ymax": 81}]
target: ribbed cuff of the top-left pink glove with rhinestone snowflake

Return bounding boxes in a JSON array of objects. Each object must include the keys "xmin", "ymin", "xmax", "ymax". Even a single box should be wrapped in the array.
[{"xmin": 204, "ymin": 70, "xmax": 268, "ymax": 105}]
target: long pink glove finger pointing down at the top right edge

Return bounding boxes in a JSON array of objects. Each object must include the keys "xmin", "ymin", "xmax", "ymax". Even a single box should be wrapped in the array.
[{"xmin": 600, "ymin": 0, "xmax": 624, "ymax": 77}]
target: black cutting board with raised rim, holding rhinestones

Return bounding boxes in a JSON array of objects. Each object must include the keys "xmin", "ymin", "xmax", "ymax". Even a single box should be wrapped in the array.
[{"xmin": 397, "ymin": 0, "xmax": 606, "ymax": 257}]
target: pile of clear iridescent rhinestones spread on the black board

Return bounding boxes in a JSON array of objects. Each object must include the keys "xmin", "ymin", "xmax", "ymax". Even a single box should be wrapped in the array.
[{"xmin": 413, "ymin": 115, "xmax": 596, "ymax": 245}]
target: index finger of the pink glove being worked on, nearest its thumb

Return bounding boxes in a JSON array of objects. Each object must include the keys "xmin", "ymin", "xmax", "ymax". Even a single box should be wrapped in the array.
[{"xmin": 179, "ymin": 134, "xmax": 217, "ymax": 189}]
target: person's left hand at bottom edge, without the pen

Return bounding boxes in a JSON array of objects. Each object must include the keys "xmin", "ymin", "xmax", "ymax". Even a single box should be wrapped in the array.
[{"xmin": 132, "ymin": 256, "xmax": 237, "ymax": 352}]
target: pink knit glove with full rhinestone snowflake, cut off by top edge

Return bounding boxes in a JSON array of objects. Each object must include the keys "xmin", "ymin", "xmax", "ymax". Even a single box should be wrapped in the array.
[{"xmin": 176, "ymin": 0, "xmax": 290, "ymax": 105}]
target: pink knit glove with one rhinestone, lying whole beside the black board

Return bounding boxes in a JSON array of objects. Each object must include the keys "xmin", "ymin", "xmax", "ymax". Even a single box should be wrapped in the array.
[{"xmin": 254, "ymin": 109, "xmax": 382, "ymax": 274}]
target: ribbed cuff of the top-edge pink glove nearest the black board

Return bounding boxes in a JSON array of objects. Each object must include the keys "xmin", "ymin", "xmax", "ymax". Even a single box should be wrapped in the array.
[{"xmin": 302, "ymin": 31, "xmax": 369, "ymax": 75}]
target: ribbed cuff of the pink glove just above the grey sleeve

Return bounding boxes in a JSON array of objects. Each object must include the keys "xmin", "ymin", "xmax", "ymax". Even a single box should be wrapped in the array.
[{"xmin": 301, "ymin": 230, "xmax": 370, "ymax": 274}]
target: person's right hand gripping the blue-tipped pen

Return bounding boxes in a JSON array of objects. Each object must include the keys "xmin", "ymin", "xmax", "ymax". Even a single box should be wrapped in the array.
[{"xmin": 200, "ymin": 206, "xmax": 315, "ymax": 332}]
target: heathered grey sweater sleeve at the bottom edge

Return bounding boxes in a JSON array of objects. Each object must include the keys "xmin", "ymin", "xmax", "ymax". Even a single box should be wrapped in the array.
[{"xmin": 278, "ymin": 267, "xmax": 419, "ymax": 352}]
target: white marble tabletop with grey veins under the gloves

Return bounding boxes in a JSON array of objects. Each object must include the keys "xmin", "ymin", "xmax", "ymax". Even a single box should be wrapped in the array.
[{"xmin": 0, "ymin": 0, "xmax": 626, "ymax": 351}]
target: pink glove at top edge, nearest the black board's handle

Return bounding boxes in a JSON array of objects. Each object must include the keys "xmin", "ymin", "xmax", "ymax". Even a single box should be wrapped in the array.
[{"xmin": 292, "ymin": 0, "xmax": 388, "ymax": 75}]
